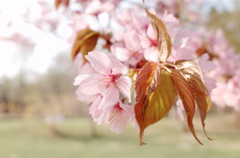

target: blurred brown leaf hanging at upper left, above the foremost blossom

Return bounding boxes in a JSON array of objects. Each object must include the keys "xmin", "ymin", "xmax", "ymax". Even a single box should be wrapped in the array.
[{"xmin": 72, "ymin": 28, "xmax": 99, "ymax": 60}]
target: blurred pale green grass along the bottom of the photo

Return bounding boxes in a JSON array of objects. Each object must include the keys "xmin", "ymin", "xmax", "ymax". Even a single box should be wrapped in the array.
[{"xmin": 0, "ymin": 115, "xmax": 240, "ymax": 158}]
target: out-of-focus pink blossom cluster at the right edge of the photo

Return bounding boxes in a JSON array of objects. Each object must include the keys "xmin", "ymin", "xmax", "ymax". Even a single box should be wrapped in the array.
[{"xmin": 192, "ymin": 29, "xmax": 240, "ymax": 111}]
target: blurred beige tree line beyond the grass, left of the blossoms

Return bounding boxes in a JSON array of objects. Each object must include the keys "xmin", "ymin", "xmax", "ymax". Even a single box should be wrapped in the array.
[{"xmin": 0, "ymin": 52, "xmax": 87, "ymax": 117}]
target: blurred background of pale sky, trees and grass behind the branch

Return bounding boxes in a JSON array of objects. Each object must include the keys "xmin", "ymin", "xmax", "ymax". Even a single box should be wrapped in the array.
[{"xmin": 0, "ymin": 0, "xmax": 240, "ymax": 158}]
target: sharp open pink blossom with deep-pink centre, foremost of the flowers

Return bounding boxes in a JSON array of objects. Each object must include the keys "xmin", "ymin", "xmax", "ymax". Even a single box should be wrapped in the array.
[{"xmin": 76, "ymin": 51, "xmax": 131, "ymax": 109}]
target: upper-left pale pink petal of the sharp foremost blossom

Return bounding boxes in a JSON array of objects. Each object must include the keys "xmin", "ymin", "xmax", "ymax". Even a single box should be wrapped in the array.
[{"xmin": 85, "ymin": 51, "xmax": 111, "ymax": 74}]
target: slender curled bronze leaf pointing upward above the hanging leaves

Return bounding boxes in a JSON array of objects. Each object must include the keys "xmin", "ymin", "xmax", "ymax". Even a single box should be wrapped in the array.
[{"xmin": 145, "ymin": 9, "xmax": 172, "ymax": 62}]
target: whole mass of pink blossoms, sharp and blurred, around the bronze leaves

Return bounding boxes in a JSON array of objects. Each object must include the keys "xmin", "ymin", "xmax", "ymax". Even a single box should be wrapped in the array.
[{"xmin": 0, "ymin": 0, "xmax": 240, "ymax": 133}]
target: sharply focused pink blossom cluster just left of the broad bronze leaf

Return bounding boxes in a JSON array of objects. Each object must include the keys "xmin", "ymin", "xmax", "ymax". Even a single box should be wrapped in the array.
[{"xmin": 74, "ymin": 51, "xmax": 135, "ymax": 133}]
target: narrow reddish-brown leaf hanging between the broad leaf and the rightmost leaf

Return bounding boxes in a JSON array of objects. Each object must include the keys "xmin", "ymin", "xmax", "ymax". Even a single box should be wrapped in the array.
[{"xmin": 172, "ymin": 69, "xmax": 203, "ymax": 145}]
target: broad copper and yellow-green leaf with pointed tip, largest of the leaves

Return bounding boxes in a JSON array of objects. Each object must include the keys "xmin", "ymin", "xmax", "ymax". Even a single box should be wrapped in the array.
[{"xmin": 134, "ymin": 62, "xmax": 175, "ymax": 145}]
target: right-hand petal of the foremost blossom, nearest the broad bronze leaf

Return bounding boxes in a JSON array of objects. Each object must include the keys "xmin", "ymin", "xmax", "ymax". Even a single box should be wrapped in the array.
[{"xmin": 116, "ymin": 76, "xmax": 132, "ymax": 102}]
